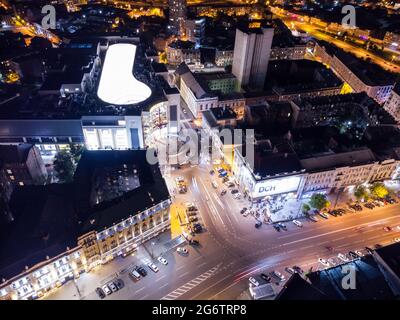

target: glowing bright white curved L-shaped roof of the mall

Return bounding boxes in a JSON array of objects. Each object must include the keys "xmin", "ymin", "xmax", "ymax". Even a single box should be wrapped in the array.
[{"xmin": 97, "ymin": 43, "xmax": 151, "ymax": 105}]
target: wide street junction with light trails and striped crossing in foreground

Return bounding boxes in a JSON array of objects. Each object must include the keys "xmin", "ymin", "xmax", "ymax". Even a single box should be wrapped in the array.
[{"xmin": 47, "ymin": 165, "xmax": 400, "ymax": 300}]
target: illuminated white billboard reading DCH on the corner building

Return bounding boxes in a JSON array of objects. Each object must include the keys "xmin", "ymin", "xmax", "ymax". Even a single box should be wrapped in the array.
[{"xmin": 252, "ymin": 176, "xmax": 301, "ymax": 198}]
